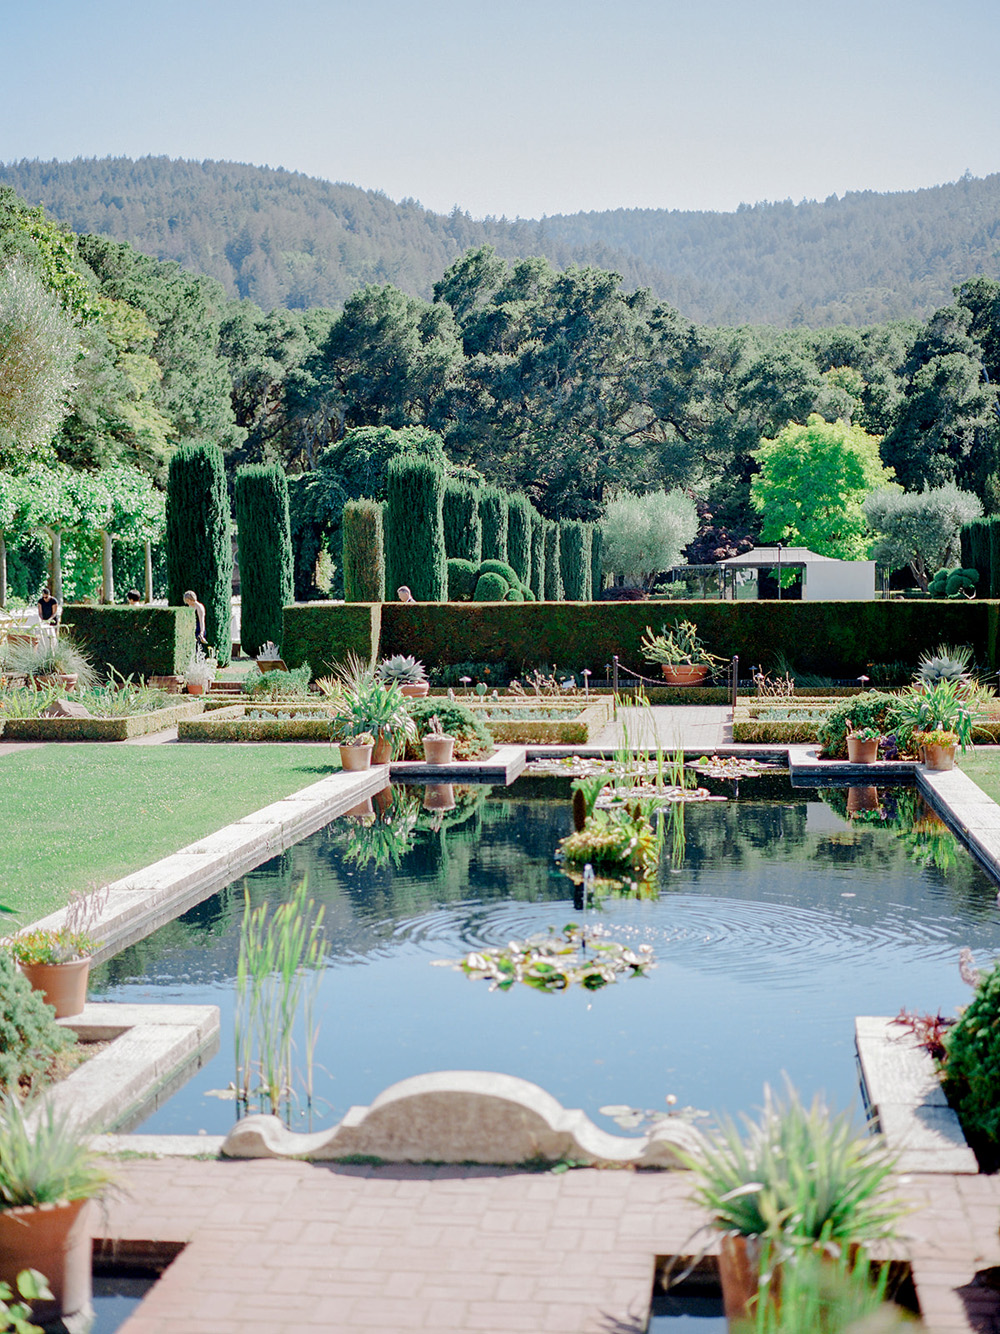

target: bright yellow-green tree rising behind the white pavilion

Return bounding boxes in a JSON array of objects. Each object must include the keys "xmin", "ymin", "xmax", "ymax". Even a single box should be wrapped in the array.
[{"xmin": 751, "ymin": 412, "xmax": 895, "ymax": 560}]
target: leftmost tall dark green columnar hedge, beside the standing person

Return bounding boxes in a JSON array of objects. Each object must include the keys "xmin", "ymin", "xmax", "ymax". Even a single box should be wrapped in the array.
[{"xmin": 165, "ymin": 444, "xmax": 232, "ymax": 667}]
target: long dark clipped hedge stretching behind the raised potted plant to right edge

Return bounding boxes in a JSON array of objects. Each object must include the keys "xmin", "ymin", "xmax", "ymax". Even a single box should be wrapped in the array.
[{"xmin": 381, "ymin": 598, "xmax": 999, "ymax": 676}]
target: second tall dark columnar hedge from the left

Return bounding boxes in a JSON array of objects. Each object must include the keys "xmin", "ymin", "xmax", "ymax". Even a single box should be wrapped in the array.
[{"xmin": 233, "ymin": 463, "xmax": 292, "ymax": 658}]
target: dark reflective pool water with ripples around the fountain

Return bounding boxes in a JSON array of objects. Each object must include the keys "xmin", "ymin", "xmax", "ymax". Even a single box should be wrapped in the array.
[{"xmin": 91, "ymin": 775, "xmax": 1000, "ymax": 1134}]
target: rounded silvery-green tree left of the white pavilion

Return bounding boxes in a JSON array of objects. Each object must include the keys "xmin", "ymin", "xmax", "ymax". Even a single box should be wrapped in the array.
[{"xmin": 600, "ymin": 491, "xmax": 697, "ymax": 588}]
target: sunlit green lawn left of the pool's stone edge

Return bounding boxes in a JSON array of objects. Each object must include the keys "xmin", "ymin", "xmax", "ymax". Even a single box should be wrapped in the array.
[{"xmin": 0, "ymin": 743, "xmax": 340, "ymax": 923}]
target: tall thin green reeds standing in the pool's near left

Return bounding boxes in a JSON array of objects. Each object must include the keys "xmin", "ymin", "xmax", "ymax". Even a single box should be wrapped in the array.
[{"xmin": 233, "ymin": 879, "xmax": 325, "ymax": 1117}]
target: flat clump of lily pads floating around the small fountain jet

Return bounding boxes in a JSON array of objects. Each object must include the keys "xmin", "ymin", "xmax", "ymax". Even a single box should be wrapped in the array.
[{"xmin": 445, "ymin": 922, "xmax": 656, "ymax": 991}]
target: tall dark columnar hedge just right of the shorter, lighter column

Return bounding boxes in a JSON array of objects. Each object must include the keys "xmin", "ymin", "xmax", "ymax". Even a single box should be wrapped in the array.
[{"xmin": 385, "ymin": 458, "xmax": 448, "ymax": 602}]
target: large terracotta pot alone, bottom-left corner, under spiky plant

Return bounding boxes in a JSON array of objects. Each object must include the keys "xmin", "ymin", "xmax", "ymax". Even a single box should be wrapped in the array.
[{"xmin": 0, "ymin": 1199, "xmax": 93, "ymax": 1322}]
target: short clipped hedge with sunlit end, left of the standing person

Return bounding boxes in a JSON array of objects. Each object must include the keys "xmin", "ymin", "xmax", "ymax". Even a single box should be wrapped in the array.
[{"xmin": 63, "ymin": 606, "xmax": 195, "ymax": 678}]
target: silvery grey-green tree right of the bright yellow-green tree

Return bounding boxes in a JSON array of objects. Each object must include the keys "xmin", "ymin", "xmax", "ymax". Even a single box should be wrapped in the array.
[{"xmin": 863, "ymin": 482, "xmax": 987, "ymax": 592}]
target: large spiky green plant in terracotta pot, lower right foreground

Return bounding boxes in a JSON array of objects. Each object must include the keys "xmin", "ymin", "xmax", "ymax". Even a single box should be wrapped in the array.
[{"xmin": 685, "ymin": 1086, "xmax": 903, "ymax": 1325}]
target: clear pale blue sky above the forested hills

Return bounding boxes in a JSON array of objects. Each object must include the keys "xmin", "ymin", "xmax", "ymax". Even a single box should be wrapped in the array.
[{"xmin": 0, "ymin": 0, "xmax": 1000, "ymax": 217}]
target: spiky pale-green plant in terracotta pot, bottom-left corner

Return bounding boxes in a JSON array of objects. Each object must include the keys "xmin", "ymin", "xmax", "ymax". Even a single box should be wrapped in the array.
[{"xmin": 0, "ymin": 1094, "xmax": 112, "ymax": 1321}]
